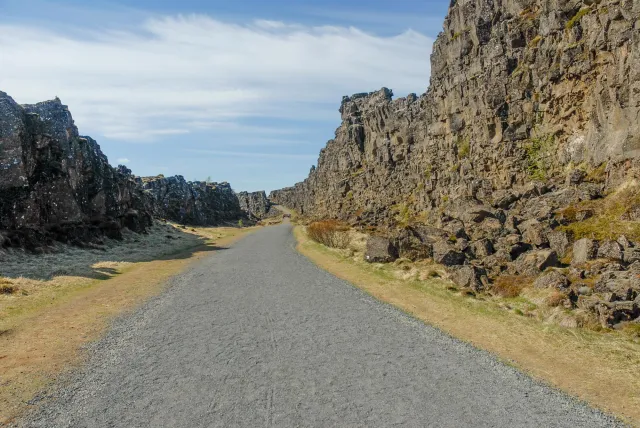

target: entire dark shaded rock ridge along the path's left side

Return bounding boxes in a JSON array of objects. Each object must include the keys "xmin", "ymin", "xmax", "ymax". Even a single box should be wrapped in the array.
[{"xmin": 0, "ymin": 92, "xmax": 270, "ymax": 249}]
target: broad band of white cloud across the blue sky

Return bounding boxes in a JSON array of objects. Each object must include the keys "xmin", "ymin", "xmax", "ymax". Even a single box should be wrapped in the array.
[{"xmin": 0, "ymin": 15, "xmax": 432, "ymax": 141}]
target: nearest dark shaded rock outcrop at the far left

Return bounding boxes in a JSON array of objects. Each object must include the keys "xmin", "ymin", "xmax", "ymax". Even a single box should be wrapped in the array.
[{"xmin": 0, "ymin": 92, "xmax": 152, "ymax": 248}]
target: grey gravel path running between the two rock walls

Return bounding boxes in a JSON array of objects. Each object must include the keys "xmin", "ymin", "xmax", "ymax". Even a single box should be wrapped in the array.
[{"xmin": 24, "ymin": 224, "xmax": 613, "ymax": 428}]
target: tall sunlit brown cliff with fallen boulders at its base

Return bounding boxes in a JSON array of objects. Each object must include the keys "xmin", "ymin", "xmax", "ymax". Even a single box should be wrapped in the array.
[{"xmin": 270, "ymin": 0, "xmax": 640, "ymax": 325}]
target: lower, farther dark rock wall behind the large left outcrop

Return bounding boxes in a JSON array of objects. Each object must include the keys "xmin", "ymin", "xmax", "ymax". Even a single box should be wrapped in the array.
[{"xmin": 138, "ymin": 175, "xmax": 244, "ymax": 226}]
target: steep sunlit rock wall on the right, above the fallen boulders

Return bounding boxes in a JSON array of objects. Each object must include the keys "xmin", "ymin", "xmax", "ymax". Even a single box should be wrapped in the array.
[{"xmin": 270, "ymin": 0, "xmax": 640, "ymax": 226}]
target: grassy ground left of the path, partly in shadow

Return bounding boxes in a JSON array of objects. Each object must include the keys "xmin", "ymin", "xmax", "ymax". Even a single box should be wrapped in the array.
[{"xmin": 0, "ymin": 224, "xmax": 254, "ymax": 425}]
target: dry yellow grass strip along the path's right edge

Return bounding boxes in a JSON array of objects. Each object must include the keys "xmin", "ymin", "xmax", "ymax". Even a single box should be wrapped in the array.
[{"xmin": 296, "ymin": 228, "xmax": 640, "ymax": 424}]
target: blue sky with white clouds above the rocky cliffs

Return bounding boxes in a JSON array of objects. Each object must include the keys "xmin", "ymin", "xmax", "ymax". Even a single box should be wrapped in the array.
[{"xmin": 0, "ymin": 0, "xmax": 449, "ymax": 191}]
